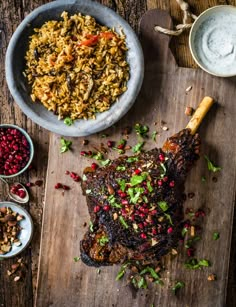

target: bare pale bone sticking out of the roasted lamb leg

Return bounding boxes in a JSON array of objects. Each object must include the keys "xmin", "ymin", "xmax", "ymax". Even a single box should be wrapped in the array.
[{"xmin": 186, "ymin": 96, "xmax": 214, "ymax": 134}]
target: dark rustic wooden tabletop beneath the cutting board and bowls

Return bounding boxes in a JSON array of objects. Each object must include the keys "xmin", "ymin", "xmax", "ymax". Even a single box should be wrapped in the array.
[{"xmin": 0, "ymin": 0, "xmax": 236, "ymax": 307}]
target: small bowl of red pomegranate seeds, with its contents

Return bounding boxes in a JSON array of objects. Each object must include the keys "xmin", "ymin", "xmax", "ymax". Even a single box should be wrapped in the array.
[{"xmin": 0, "ymin": 124, "xmax": 34, "ymax": 178}]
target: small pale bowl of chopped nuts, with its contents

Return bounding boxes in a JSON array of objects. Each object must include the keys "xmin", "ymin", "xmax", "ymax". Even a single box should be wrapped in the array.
[{"xmin": 0, "ymin": 201, "xmax": 33, "ymax": 259}]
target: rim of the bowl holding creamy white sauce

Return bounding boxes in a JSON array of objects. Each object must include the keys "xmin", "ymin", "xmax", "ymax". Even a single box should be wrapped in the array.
[{"xmin": 189, "ymin": 4, "xmax": 236, "ymax": 78}]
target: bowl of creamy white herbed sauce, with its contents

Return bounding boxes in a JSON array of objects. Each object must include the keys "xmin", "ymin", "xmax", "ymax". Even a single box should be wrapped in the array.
[{"xmin": 189, "ymin": 5, "xmax": 236, "ymax": 77}]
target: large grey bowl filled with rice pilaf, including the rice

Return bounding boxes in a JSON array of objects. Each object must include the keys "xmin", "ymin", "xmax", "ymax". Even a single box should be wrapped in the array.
[{"xmin": 6, "ymin": 0, "xmax": 144, "ymax": 136}]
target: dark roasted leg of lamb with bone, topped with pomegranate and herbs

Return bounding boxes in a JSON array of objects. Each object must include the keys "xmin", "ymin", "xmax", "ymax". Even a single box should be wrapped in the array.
[{"xmin": 80, "ymin": 97, "xmax": 213, "ymax": 267}]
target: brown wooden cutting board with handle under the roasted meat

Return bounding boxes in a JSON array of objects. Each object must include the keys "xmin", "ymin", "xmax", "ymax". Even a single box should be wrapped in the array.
[{"xmin": 36, "ymin": 9, "xmax": 236, "ymax": 307}]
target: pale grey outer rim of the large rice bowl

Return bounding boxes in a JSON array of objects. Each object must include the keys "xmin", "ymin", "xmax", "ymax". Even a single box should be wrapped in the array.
[{"xmin": 5, "ymin": 0, "xmax": 144, "ymax": 137}]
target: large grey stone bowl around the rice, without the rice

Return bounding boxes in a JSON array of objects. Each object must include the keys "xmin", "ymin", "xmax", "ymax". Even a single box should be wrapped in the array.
[{"xmin": 5, "ymin": 0, "xmax": 144, "ymax": 137}]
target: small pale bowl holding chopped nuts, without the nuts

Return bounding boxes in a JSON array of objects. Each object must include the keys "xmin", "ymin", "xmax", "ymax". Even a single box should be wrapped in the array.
[{"xmin": 0, "ymin": 201, "xmax": 33, "ymax": 259}]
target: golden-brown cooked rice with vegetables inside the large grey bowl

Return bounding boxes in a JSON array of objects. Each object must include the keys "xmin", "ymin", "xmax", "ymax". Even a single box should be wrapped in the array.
[{"xmin": 24, "ymin": 12, "xmax": 129, "ymax": 119}]
